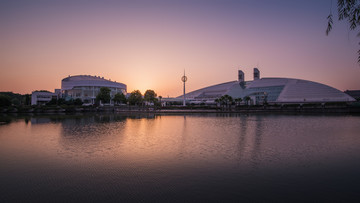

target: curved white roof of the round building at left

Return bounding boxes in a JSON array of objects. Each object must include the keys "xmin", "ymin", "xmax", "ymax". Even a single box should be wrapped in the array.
[{"xmin": 61, "ymin": 75, "xmax": 126, "ymax": 90}]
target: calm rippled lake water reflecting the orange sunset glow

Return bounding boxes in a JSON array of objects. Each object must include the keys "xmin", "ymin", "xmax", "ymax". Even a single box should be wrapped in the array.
[{"xmin": 0, "ymin": 114, "xmax": 360, "ymax": 202}]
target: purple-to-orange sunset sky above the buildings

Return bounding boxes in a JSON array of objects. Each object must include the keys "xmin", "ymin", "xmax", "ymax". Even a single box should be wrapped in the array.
[{"xmin": 0, "ymin": 0, "xmax": 360, "ymax": 97}]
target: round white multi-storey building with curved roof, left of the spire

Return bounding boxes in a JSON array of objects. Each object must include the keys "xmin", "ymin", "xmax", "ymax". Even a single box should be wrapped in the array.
[{"xmin": 61, "ymin": 75, "xmax": 126, "ymax": 104}]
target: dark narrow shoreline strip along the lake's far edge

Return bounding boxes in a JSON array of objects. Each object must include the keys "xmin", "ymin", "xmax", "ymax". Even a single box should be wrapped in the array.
[{"xmin": 0, "ymin": 106, "xmax": 360, "ymax": 115}]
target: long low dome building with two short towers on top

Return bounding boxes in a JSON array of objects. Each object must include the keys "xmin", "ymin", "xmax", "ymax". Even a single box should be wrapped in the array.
[{"xmin": 178, "ymin": 68, "xmax": 355, "ymax": 104}]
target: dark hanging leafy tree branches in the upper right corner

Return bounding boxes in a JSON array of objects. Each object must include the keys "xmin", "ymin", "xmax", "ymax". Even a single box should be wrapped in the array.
[{"xmin": 326, "ymin": 0, "xmax": 360, "ymax": 63}]
